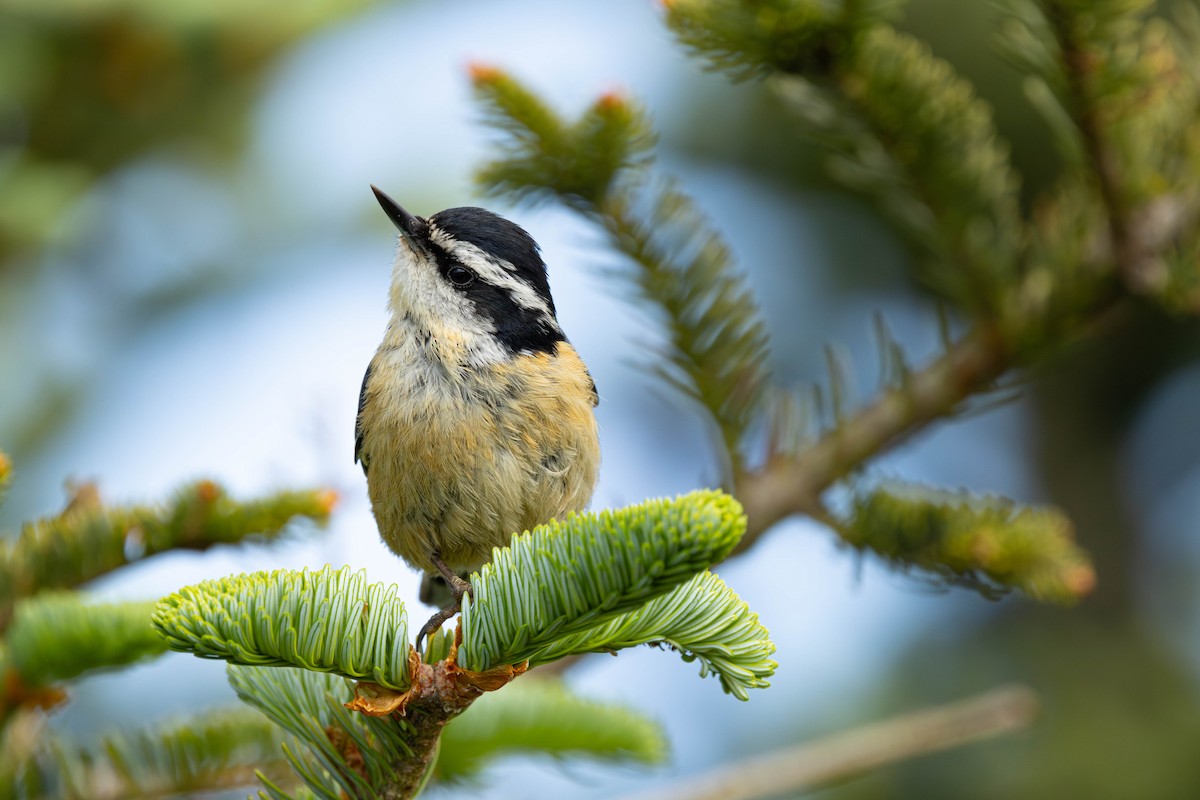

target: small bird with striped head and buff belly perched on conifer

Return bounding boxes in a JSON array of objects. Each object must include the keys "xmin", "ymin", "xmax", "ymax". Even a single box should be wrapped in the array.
[{"xmin": 354, "ymin": 185, "xmax": 600, "ymax": 650}]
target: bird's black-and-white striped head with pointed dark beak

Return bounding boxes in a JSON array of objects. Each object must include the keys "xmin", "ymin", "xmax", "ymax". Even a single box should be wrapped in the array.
[{"xmin": 371, "ymin": 186, "xmax": 564, "ymax": 362}]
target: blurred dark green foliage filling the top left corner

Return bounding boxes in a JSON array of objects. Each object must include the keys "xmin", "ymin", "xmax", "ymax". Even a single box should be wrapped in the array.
[{"xmin": 0, "ymin": 0, "xmax": 376, "ymax": 268}]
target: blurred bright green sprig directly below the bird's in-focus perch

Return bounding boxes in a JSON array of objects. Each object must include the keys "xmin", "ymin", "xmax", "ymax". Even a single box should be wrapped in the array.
[{"xmin": 434, "ymin": 679, "xmax": 667, "ymax": 782}]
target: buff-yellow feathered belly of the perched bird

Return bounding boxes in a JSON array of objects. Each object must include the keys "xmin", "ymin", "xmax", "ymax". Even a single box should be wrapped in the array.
[{"xmin": 357, "ymin": 362, "xmax": 598, "ymax": 571}]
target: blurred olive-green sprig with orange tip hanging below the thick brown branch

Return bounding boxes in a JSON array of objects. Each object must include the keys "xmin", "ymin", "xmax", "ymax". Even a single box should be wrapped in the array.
[{"xmin": 840, "ymin": 485, "xmax": 1096, "ymax": 603}]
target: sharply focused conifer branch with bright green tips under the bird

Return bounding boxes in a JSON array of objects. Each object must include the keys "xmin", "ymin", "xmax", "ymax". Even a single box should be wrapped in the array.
[{"xmin": 152, "ymin": 491, "xmax": 775, "ymax": 799}]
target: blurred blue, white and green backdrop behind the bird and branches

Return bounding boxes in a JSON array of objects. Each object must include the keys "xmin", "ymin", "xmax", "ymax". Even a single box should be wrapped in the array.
[{"xmin": 7, "ymin": 0, "xmax": 1200, "ymax": 798}]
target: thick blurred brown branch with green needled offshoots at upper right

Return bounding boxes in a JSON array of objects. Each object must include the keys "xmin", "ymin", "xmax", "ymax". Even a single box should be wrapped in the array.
[{"xmin": 664, "ymin": 0, "xmax": 1200, "ymax": 582}]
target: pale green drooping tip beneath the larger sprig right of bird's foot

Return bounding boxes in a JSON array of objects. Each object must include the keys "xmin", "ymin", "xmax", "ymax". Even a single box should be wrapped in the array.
[{"xmin": 529, "ymin": 572, "xmax": 778, "ymax": 700}]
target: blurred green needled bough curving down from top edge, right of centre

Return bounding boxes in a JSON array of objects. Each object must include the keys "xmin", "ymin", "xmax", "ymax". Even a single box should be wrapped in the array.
[{"xmin": 666, "ymin": 0, "xmax": 1021, "ymax": 317}]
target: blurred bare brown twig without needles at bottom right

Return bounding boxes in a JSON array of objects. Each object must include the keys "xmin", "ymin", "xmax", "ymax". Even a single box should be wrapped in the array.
[{"xmin": 626, "ymin": 686, "xmax": 1038, "ymax": 800}]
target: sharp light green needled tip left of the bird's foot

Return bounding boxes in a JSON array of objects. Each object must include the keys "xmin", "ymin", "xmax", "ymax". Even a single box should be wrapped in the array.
[{"xmin": 152, "ymin": 566, "xmax": 410, "ymax": 690}]
